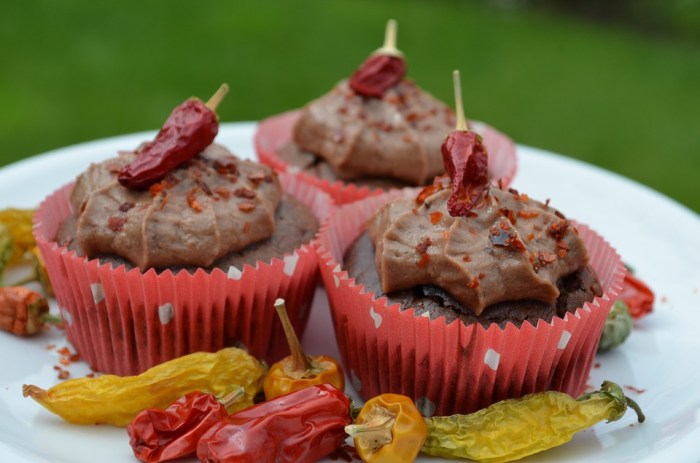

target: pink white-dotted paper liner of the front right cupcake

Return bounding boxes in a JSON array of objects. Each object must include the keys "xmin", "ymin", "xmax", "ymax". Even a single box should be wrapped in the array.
[{"xmin": 318, "ymin": 190, "xmax": 624, "ymax": 416}]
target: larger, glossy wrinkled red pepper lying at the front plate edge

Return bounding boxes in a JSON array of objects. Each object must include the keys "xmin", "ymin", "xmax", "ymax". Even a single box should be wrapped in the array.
[{"xmin": 197, "ymin": 384, "xmax": 351, "ymax": 463}]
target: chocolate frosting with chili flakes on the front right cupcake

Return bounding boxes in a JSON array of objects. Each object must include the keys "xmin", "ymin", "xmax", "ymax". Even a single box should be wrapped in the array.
[{"xmin": 368, "ymin": 178, "xmax": 588, "ymax": 316}]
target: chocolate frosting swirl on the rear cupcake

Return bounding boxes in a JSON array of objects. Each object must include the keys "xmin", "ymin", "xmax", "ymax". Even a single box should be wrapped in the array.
[{"xmin": 293, "ymin": 79, "xmax": 454, "ymax": 185}]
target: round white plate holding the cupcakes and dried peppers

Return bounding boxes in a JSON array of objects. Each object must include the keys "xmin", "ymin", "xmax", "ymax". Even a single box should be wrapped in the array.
[{"xmin": 0, "ymin": 123, "xmax": 700, "ymax": 463}]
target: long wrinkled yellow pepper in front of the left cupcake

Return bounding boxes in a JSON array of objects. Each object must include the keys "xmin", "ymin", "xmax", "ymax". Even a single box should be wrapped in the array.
[{"xmin": 22, "ymin": 347, "xmax": 265, "ymax": 426}]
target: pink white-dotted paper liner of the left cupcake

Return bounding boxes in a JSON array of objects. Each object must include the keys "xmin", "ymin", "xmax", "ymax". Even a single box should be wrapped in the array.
[{"xmin": 34, "ymin": 174, "xmax": 334, "ymax": 375}]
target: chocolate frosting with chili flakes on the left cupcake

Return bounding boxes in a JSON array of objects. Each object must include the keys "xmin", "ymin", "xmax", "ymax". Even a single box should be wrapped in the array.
[{"xmin": 71, "ymin": 144, "xmax": 282, "ymax": 269}]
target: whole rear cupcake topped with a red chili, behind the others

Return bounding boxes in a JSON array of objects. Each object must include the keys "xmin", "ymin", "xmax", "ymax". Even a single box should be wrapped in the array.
[{"xmin": 255, "ymin": 21, "xmax": 516, "ymax": 204}]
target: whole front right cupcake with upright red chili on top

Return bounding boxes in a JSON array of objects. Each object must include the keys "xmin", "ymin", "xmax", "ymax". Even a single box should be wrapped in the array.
[{"xmin": 318, "ymin": 73, "xmax": 623, "ymax": 416}]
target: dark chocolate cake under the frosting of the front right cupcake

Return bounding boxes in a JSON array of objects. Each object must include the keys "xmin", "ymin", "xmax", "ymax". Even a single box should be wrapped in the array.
[{"xmin": 344, "ymin": 232, "xmax": 602, "ymax": 328}]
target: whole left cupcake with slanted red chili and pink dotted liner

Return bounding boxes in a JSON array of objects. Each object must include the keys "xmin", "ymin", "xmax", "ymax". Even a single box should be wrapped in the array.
[{"xmin": 34, "ymin": 86, "xmax": 332, "ymax": 375}]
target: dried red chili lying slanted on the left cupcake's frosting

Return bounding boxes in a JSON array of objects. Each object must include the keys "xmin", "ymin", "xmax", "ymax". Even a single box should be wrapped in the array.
[{"xmin": 118, "ymin": 84, "xmax": 228, "ymax": 189}]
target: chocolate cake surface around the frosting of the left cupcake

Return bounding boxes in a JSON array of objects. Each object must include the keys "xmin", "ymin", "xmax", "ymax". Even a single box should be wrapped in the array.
[{"xmin": 56, "ymin": 195, "xmax": 318, "ymax": 273}]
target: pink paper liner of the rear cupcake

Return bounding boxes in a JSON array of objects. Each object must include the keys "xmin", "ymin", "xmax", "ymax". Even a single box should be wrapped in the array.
[{"xmin": 253, "ymin": 110, "xmax": 518, "ymax": 204}]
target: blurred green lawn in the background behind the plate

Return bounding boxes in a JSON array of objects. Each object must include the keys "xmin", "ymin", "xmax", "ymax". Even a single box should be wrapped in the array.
[{"xmin": 0, "ymin": 0, "xmax": 700, "ymax": 212}]
